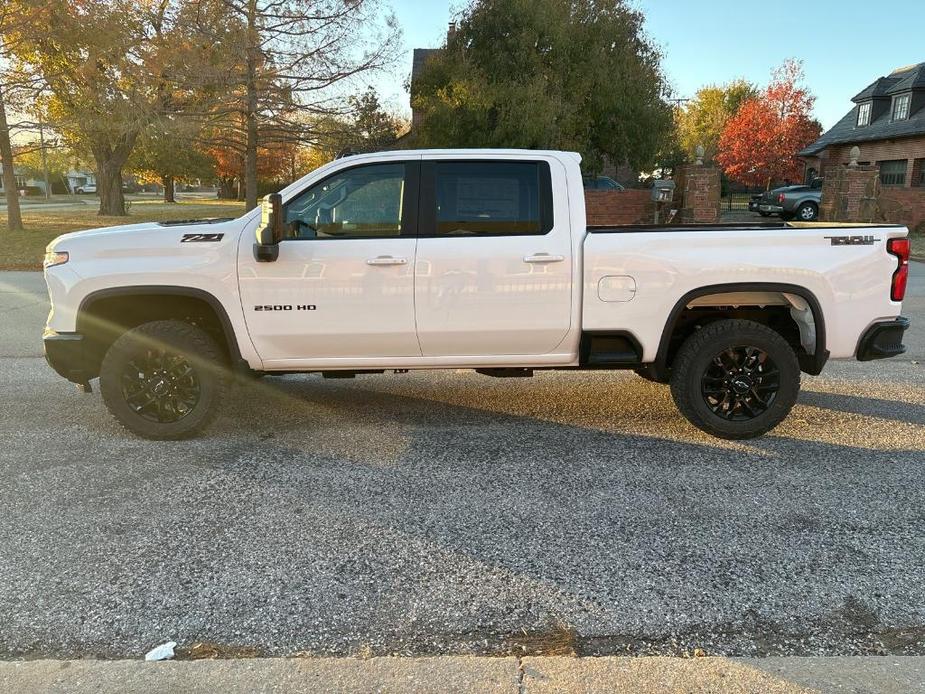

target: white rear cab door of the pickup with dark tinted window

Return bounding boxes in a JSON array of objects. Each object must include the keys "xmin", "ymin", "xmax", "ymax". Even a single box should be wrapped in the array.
[{"xmin": 414, "ymin": 155, "xmax": 572, "ymax": 357}]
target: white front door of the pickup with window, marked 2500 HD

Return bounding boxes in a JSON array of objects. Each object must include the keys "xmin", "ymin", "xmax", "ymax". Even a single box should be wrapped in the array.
[{"xmin": 239, "ymin": 161, "xmax": 421, "ymax": 369}]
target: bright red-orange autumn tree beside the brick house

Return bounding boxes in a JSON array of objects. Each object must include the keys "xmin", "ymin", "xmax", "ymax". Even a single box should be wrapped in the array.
[{"xmin": 716, "ymin": 60, "xmax": 822, "ymax": 187}]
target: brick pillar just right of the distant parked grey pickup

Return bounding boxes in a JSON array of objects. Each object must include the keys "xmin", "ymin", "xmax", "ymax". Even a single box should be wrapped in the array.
[{"xmin": 819, "ymin": 166, "xmax": 883, "ymax": 222}]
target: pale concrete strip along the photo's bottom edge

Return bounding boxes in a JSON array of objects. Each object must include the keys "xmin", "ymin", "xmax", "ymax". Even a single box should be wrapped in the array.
[{"xmin": 0, "ymin": 656, "xmax": 925, "ymax": 694}]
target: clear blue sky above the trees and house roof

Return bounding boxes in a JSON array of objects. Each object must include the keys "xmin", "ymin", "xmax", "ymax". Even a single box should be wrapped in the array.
[{"xmin": 374, "ymin": 0, "xmax": 925, "ymax": 129}]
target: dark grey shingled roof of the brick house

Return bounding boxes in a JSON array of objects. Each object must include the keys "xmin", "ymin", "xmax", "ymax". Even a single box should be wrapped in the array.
[{"xmin": 799, "ymin": 63, "xmax": 925, "ymax": 157}]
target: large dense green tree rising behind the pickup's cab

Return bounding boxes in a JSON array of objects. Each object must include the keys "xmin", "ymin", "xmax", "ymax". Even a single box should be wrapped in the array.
[{"xmin": 411, "ymin": 0, "xmax": 672, "ymax": 172}]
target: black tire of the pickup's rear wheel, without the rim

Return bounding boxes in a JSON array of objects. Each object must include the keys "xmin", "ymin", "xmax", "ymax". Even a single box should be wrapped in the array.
[{"xmin": 671, "ymin": 320, "xmax": 800, "ymax": 439}]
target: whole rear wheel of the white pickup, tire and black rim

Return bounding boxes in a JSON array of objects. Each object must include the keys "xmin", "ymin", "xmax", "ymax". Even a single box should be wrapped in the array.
[{"xmin": 671, "ymin": 320, "xmax": 800, "ymax": 439}]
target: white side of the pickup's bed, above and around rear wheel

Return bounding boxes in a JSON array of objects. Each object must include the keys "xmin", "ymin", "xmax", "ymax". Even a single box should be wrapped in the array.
[{"xmin": 582, "ymin": 222, "xmax": 907, "ymax": 362}]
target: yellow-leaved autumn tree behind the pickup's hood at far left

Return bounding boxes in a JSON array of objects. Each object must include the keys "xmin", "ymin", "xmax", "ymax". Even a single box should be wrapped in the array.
[{"xmin": 5, "ymin": 0, "xmax": 209, "ymax": 215}]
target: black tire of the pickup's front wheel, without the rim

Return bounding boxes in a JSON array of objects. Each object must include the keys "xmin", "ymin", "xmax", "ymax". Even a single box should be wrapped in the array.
[{"xmin": 100, "ymin": 320, "xmax": 230, "ymax": 441}]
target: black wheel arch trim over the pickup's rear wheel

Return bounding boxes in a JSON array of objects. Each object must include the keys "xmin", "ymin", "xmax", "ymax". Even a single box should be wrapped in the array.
[{"xmin": 655, "ymin": 282, "xmax": 829, "ymax": 375}]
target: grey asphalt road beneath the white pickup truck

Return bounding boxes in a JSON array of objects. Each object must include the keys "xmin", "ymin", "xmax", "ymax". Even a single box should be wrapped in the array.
[{"xmin": 0, "ymin": 264, "xmax": 925, "ymax": 658}]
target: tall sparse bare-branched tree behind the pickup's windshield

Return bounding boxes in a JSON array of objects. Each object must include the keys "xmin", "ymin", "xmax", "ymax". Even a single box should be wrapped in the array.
[{"xmin": 191, "ymin": 0, "xmax": 400, "ymax": 209}]
